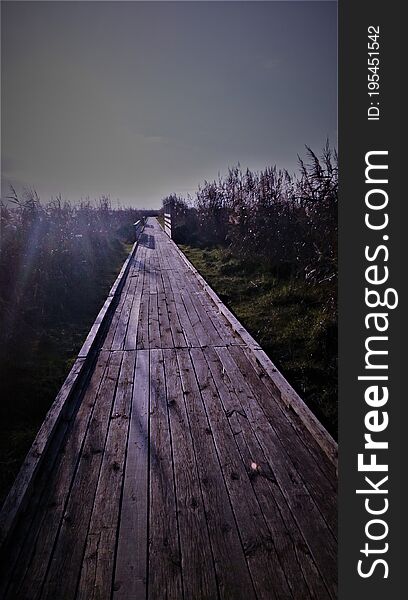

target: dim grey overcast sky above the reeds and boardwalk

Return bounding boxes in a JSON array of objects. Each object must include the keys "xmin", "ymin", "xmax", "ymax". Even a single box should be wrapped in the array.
[{"xmin": 1, "ymin": 1, "xmax": 337, "ymax": 207}]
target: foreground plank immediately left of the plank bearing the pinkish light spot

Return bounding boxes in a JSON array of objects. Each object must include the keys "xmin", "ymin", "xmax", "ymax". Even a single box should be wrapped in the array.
[{"xmin": 190, "ymin": 348, "xmax": 292, "ymax": 600}]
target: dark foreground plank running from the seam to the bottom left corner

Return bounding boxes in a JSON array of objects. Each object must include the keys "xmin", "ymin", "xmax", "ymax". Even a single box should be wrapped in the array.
[{"xmin": 6, "ymin": 352, "xmax": 109, "ymax": 600}]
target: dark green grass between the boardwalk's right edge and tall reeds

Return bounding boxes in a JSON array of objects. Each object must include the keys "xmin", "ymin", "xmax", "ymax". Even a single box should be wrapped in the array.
[{"xmin": 180, "ymin": 246, "xmax": 337, "ymax": 437}]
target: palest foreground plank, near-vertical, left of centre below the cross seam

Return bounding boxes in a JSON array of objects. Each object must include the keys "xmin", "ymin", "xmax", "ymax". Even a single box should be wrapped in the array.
[{"xmin": 113, "ymin": 350, "xmax": 150, "ymax": 600}]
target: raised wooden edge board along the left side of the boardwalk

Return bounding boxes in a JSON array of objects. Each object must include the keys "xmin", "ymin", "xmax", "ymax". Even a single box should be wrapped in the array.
[{"xmin": 0, "ymin": 229, "xmax": 143, "ymax": 547}]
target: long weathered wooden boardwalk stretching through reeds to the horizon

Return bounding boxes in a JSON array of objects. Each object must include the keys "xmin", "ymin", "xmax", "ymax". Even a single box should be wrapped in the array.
[{"xmin": 0, "ymin": 219, "xmax": 337, "ymax": 600}]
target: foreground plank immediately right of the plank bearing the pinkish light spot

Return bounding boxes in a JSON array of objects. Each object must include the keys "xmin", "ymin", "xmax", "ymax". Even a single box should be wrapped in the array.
[{"xmin": 215, "ymin": 347, "xmax": 337, "ymax": 598}]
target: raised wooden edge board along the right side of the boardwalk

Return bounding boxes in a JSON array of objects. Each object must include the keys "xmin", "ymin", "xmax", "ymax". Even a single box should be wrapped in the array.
[{"xmin": 173, "ymin": 237, "xmax": 338, "ymax": 469}]
